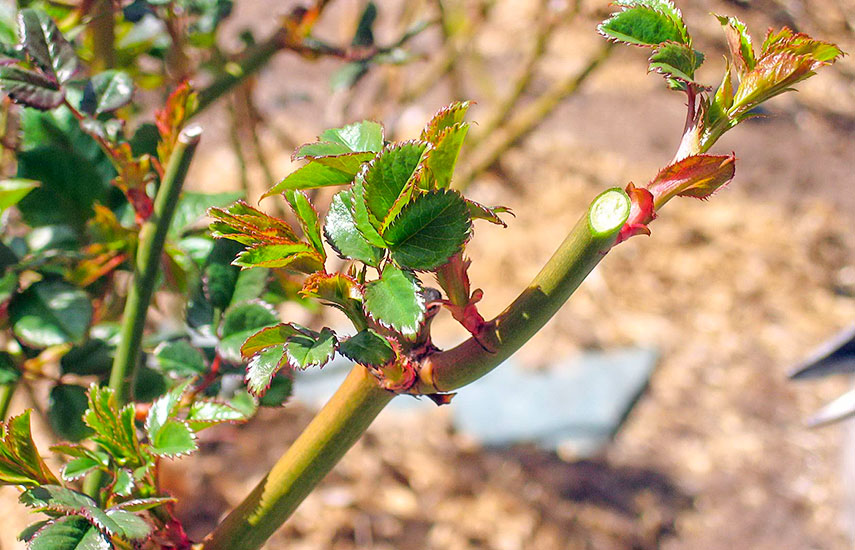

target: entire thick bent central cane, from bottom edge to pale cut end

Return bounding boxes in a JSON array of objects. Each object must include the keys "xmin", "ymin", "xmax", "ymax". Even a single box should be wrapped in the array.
[{"xmin": 200, "ymin": 188, "xmax": 630, "ymax": 550}]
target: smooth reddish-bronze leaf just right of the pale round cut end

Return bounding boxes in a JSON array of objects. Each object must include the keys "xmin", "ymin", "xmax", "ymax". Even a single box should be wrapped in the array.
[{"xmin": 647, "ymin": 155, "xmax": 736, "ymax": 209}]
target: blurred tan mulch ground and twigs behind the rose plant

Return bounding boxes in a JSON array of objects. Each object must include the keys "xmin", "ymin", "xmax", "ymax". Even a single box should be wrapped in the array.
[{"xmin": 0, "ymin": 0, "xmax": 855, "ymax": 550}]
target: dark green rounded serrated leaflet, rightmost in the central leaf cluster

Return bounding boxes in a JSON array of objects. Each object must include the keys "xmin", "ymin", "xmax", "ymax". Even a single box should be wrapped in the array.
[{"xmin": 383, "ymin": 190, "xmax": 472, "ymax": 271}]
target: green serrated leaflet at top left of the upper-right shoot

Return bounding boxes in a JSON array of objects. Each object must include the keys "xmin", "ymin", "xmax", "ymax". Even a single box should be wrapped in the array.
[{"xmin": 597, "ymin": 0, "xmax": 691, "ymax": 46}]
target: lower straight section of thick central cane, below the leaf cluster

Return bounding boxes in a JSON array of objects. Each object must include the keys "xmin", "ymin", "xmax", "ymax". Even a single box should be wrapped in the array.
[{"xmin": 202, "ymin": 365, "xmax": 395, "ymax": 550}]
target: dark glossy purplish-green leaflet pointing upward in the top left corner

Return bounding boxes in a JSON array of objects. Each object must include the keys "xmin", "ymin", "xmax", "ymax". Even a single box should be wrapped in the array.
[{"xmin": 18, "ymin": 9, "xmax": 81, "ymax": 84}]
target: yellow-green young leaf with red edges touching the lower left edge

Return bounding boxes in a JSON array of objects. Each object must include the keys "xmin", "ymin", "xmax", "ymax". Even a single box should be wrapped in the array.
[{"xmin": 0, "ymin": 410, "xmax": 59, "ymax": 486}]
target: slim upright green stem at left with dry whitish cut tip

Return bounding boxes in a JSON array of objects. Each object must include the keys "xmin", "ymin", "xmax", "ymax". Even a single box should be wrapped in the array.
[{"xmin": 110, "ymin": 126, "xmax": 202, "ymax": 403}]
